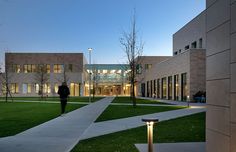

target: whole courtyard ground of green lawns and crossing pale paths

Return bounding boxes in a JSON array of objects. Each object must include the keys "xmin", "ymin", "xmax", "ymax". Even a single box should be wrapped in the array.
[{"xmin": 0, "ymin": 97, "xmax": 205, "ymax": 152}]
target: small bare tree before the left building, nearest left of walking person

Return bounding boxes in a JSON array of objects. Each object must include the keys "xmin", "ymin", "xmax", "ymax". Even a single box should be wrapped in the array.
[{"xmin": 35, "ymin": 64, "xmax": 49, "ymax": 99}]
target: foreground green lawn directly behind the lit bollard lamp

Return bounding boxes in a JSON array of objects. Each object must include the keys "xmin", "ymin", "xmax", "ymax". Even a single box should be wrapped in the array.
[{"xmin": 72, "ymin": 113, "xmax": 205, "ymax": 152}]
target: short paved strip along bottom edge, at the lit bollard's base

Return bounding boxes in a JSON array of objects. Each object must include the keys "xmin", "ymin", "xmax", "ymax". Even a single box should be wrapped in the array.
[{"xmin": 135, "ymin": 142, "xmax": 206, "ymax": 152}]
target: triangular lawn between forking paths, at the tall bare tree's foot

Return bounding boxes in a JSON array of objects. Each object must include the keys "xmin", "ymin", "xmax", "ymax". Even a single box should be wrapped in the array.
[{"xmin": 96, "ymin": 105, "xmax": 185, "ymax": 122}]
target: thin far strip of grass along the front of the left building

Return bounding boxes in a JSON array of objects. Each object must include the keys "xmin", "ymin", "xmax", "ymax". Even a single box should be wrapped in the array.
[{"xmin": 0, "ymin": 97, "xmax": 103, "ymax": 102}]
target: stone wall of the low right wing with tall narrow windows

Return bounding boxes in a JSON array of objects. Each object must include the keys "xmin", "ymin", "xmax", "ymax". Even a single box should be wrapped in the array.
[{"xmin": 138, "ymin": 49, "xmax": 206, "ymax": 100}]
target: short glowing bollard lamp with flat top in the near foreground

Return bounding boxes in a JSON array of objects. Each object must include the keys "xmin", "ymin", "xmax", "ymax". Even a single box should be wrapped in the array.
[{"xmin": 142, "ymin": 118, "xmax": 158, "ymax": 152}]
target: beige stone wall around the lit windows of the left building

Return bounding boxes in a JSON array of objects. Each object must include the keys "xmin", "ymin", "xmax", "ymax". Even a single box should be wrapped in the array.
[{"xmin": 5, "ymin": 53, "xmax": 84, "ymax": 96}]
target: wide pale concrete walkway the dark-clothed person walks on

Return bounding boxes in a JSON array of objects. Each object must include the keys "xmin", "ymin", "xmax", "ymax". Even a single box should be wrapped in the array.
[{"xmin": 0, "ymin": 97, "xmax": 113, "ymax": 152}]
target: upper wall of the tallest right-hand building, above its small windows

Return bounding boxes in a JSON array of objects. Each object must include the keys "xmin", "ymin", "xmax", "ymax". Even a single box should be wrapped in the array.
[{"xmin": 173, "ymin": 11, "xmax": 206, "ymax": 55}]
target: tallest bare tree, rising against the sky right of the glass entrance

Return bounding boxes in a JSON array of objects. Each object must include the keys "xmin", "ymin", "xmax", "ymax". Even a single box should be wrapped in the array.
[{"xmin": 120, "ymin": 15, "xmax": 143, "ymax": 107}]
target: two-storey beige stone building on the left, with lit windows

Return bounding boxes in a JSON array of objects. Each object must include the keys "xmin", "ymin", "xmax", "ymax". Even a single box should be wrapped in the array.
[{"xmin": 1, "ymin": 53, "xmax": 86, "ymax": 96}]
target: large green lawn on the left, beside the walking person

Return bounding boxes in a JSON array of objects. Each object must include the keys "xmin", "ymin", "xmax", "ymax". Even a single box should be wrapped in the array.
[{"xmin": 0, "ymin": 102, "xmax": 82, "ymax": 137}]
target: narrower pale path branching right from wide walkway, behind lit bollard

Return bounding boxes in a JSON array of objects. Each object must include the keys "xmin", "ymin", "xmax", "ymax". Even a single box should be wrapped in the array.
[{"xmin": 81, "ymin": 107, "xmax": 206, "ymax": 139}]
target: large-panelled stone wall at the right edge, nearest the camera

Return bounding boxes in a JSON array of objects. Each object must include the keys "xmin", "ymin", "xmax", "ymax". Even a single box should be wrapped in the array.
[{"xmin": 206, "ymin": 0, "xmax": 236, "ymax": 152}]
